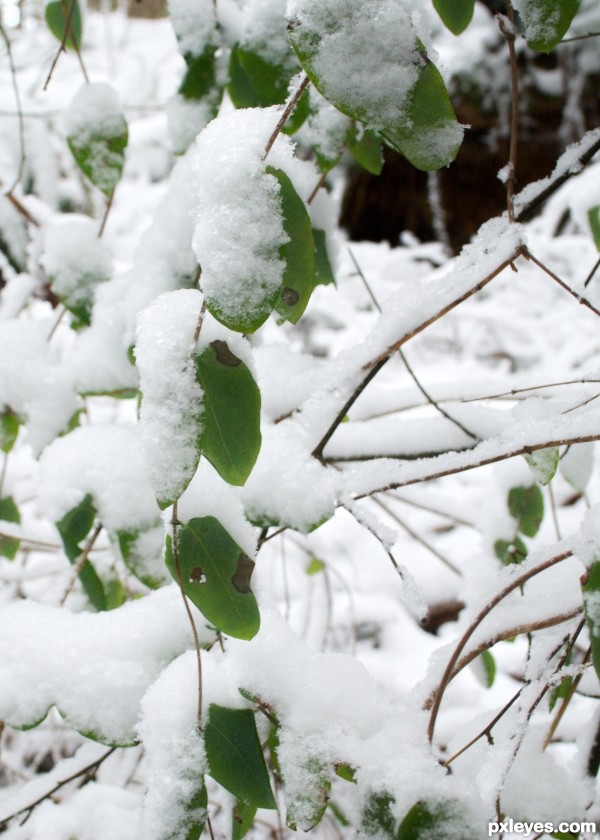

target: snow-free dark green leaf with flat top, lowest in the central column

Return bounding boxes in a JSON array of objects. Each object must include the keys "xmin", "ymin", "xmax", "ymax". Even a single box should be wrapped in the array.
[{"xmin": 204, "ymin": 703, "xmax": 277, "ymax": 809}]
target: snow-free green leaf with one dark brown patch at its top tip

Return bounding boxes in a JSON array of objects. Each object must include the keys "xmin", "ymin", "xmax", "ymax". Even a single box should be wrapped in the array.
[{"xmin": 195, "ymin": 340, "xmax": 262, "ymax": 485}]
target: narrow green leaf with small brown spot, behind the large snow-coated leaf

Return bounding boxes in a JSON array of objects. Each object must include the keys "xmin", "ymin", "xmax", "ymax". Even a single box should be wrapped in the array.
[{"xmin": 267, "ymin": 166, "xmax": 315, "ymax": 324}]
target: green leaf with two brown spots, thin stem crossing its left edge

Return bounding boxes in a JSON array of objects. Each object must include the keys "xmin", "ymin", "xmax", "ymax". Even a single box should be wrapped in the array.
[{"xmin": 166, "ymin": 516, "xmax": 260, "ymax": 639}]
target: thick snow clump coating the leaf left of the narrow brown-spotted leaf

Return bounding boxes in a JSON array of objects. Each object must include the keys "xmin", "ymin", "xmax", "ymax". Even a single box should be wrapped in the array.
[{"xmin": 193, "ymin": 107, "xmax": 289, "ymax": 328}]
